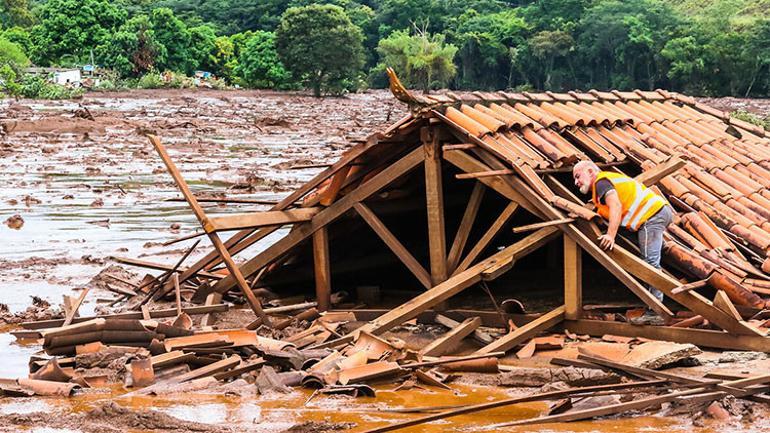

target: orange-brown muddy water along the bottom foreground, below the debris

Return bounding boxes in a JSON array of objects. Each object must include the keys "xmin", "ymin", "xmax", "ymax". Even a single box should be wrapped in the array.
[{"xmin": 0, "ymin": 386, "xmax": 736, "ymax": 433}]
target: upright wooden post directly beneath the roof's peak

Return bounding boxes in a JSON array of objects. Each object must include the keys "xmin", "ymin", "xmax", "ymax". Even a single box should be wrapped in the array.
[{"xmin": 420, "ymin": 127, "xmax": 449, "ymax": 286}]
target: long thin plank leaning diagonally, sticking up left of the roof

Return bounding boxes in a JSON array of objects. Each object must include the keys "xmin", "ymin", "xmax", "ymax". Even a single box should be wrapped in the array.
[{"xmin": 147, "ymin": 134, "xmax": 270, "ymax": 325}]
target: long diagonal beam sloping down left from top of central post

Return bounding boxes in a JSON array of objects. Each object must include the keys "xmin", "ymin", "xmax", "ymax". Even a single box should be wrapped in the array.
[{"xmin": 213, "ymin": 148, "xmax": 423, "ymax": 293}]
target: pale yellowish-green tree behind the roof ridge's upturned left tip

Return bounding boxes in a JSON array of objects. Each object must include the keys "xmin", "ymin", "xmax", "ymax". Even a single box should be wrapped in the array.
[{"xmin": 377, "ymin": 30, "xmax": 457, "ymax": 92}]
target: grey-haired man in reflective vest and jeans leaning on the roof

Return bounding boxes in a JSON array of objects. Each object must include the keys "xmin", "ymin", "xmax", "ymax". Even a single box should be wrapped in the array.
[{"xmin": 572, "ymin": 161, "xmax": 674, "ymax": 324}]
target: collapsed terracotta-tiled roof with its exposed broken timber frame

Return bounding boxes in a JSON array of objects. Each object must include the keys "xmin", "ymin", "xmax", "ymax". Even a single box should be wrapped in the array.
[{"xmin": 135, "ymin": 71, "xmax": 770, "ymax": 352}]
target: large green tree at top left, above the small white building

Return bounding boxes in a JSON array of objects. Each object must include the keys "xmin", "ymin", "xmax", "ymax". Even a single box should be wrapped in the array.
[{"xmin": 31, "ymin": 0, "xmax": 127, "ymax": 66}]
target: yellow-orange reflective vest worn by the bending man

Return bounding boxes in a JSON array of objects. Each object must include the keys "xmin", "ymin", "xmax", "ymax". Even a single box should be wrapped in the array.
[{"xmin": 591, "ymin": 171, "xmax": 668, "ymax": 231}]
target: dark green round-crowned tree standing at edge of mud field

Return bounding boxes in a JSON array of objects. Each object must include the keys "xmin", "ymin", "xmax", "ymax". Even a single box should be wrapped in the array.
[{"xmin": 276, "ymin": 5, "xmax": 364, "ymax": 96}]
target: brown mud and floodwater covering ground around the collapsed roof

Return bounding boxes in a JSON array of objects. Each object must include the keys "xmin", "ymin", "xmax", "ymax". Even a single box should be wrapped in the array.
[{"xmin": 0, "ymin": 90, "xmax": 770, "ymax": 433}]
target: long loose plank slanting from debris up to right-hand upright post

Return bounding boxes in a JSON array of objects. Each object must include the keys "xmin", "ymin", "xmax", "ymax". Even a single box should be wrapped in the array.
[{"xmin": 316, "ymin": 227, "xmax": 558, "ymax": 348}]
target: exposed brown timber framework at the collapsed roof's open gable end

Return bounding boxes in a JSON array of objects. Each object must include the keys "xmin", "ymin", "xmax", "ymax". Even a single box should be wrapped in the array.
[{"xmin": 150, "ymin": 111, "xmax": 770, "ymax": 354}]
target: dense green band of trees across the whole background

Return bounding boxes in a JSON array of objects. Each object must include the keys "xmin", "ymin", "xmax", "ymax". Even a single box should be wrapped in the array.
[{"xmin": 0, "ymin": 0, "xmax": 770, "ymax": 96}]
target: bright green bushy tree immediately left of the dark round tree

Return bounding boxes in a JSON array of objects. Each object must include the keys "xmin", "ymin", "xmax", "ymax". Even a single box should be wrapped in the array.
[{"xmin": 235, "ymin": 30, "xmax": 290, "ymax": 88}]
